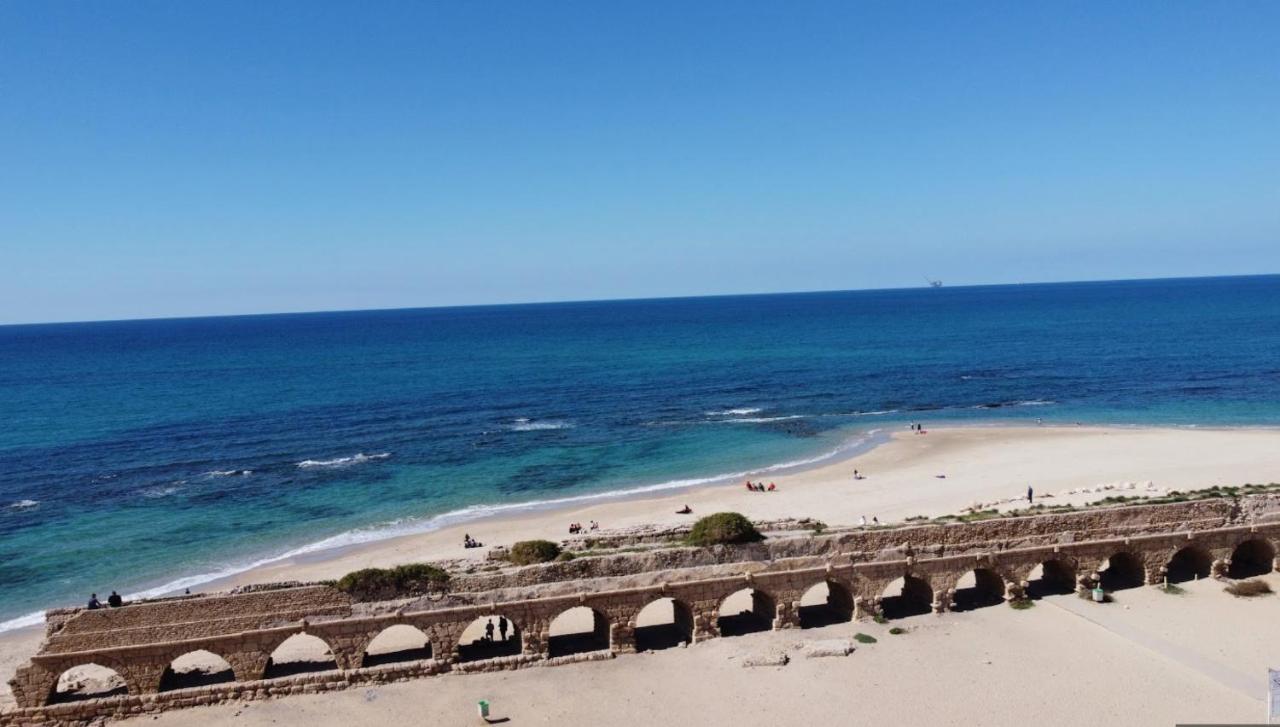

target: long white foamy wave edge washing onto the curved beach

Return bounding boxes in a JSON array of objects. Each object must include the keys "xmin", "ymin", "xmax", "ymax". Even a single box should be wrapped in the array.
[{"xmin": 0, "ymin": 429, "xmax": 887, "ymax": 632}]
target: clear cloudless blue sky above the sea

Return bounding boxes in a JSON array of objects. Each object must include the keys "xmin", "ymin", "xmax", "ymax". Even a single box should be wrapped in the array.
[{"xmin": 0, "ymin": 0, "xmax": 1280, "ymax": 323}]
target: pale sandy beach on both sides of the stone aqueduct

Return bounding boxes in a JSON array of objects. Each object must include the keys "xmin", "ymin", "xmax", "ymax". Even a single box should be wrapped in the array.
[{"xmin": 0, "ymin": 426, "xmax": 1280, "ymax": 724}]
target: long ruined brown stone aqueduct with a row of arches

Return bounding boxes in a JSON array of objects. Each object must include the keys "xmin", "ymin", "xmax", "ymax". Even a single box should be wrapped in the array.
[{"xmin": 0, "ymin": 495, "xmax": 1280, "ymax": 726}]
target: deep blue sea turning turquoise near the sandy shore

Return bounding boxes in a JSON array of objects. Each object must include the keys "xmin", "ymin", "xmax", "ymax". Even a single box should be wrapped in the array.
[{"xmin": 0, "ymin": 276, "xmax": 1280, "ymax": 621}]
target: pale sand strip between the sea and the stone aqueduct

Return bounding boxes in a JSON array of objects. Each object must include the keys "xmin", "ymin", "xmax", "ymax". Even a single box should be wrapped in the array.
[{"xmin": 0, "ymin": 427, "xmax": 1280, "ymax": 717}]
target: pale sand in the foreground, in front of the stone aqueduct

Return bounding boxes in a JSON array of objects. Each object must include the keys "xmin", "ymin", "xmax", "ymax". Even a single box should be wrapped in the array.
[{"xmin": 128, "ymin": 573, "xmax": 1280, "ymax": 727}]
